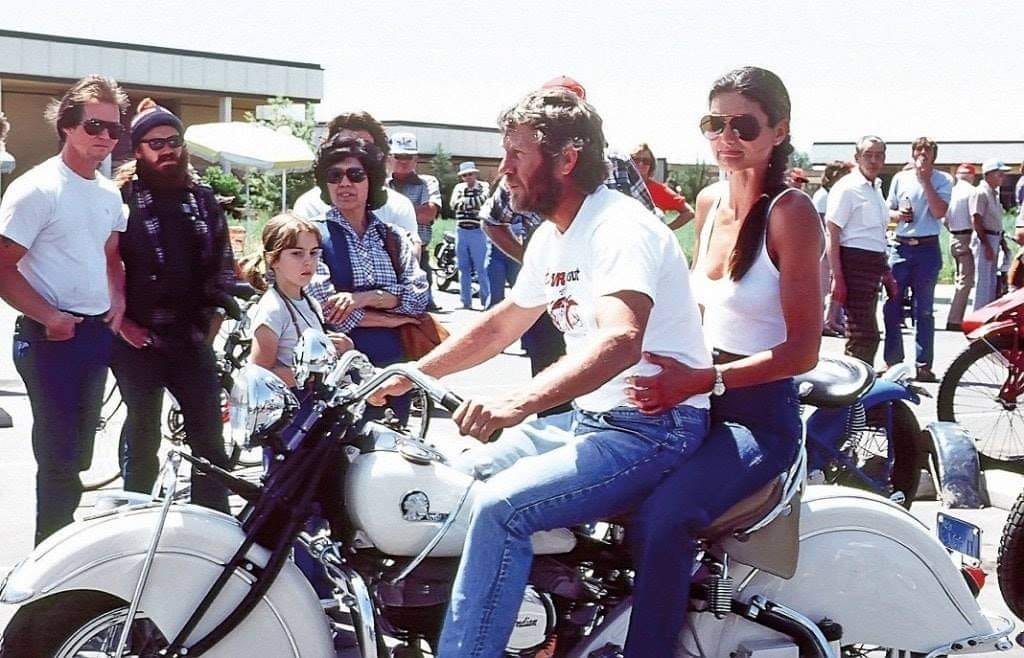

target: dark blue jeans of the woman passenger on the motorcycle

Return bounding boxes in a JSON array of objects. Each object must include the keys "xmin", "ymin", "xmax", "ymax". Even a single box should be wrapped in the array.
[{"xmin": 626, "ymin": 380, "xmax": 802, "ymax": 658}]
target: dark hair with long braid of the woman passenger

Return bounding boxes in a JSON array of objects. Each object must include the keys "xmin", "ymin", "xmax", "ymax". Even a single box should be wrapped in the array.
[{"xmin": 708, "ymin": 67, "xmax": 793, "ymax": 281}]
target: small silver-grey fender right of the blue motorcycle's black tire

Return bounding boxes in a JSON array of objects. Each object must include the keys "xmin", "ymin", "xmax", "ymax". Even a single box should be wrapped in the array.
[{"xmin": 925, "ymin": 421, "xmax": 988, "ymax": 510}]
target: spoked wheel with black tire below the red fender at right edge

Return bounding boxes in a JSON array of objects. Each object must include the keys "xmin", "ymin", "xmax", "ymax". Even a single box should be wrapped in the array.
[{"xmin": 936, "ymin": 337, "xmax": 1024, "ymax": 467}]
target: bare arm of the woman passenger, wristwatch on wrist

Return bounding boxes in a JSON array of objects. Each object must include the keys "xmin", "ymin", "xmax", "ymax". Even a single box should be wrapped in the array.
[{"xmin": 627, "ymin": 190, "xmax": 824, "ymax": 413}]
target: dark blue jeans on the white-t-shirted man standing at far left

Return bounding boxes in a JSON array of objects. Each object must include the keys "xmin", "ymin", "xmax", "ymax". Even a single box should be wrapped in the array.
[{"xmin": 13, "ymin": 315, "xmax": 114, "ymax": 544}]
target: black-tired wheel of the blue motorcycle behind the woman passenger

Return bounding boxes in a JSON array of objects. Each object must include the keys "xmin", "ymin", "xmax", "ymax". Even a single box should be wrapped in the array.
[{"xmin": 829, "ymin": 401, "xmax": 927, "ymax": 509}]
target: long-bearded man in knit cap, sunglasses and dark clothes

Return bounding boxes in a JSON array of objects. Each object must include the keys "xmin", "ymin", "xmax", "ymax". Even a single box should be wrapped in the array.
[{"xmin": 111, "ymin": 98, "xmax": 233, "ymax": 512}]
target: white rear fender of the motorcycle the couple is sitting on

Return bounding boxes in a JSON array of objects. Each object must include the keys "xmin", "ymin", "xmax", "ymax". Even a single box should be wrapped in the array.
[{"xmin": 570, "ymin": 485, "xmax": 1013, "ymax": 657}]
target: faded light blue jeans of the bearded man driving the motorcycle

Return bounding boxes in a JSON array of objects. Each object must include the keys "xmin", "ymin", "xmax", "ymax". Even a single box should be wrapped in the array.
[{"xmin": 437, "ymin": 406, "xmax": 708, "ymax": 658}]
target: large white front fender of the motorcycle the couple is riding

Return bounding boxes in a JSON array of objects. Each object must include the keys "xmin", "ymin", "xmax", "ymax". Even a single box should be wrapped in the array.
[{"xmin": 0, "ymin": 505, "xmax": 335, "ymax": 658}]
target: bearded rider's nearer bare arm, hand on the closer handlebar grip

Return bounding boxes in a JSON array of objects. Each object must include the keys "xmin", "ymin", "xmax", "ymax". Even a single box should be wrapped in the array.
[{"xmin": 452, "ymin": 291, "xmax": 653, "ymax": 441}]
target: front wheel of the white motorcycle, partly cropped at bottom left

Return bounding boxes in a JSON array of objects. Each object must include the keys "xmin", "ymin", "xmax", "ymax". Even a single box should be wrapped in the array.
[{"xmin": 0, "ymin": 591, "xmax": 168, "ymax": 658}]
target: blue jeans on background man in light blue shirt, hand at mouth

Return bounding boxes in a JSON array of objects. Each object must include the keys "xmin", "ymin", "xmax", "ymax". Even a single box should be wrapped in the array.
[{"xmin": 882, "ymin": 240, "xmax": 942, "ymax": 368}]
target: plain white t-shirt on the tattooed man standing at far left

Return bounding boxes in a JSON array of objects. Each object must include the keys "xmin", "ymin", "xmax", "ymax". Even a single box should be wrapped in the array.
[{"xmin": 0, "ymin": 155, "xmax": 128, "ymax": 315}]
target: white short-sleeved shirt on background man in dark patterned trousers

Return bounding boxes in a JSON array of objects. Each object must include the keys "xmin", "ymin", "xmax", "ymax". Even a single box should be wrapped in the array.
[{"xmin": 825, "ymin": 168, "xmax": 889, "ymax": 253}]
